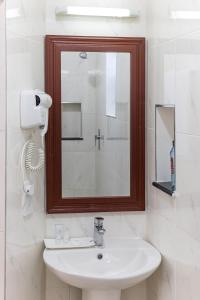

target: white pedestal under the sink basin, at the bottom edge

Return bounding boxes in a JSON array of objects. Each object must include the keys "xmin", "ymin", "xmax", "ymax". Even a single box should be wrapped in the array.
[{"xmin": 82, "ymin": 290, "xmax": 121, "ymax": 300}]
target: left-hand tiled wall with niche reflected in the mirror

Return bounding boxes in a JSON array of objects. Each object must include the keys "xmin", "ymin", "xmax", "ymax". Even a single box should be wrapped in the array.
[{"xmin": 61, "ymin": 52, "xmax": 96, "ymax": 197}]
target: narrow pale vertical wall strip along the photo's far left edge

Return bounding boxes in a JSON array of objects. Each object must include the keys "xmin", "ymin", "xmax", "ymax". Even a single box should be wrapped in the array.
[{"xmin": 0, "ymin": 2, "xmax": 6, "ymax": 300}]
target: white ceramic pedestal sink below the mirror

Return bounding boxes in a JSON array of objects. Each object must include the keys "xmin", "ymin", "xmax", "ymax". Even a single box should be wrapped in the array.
[{"xmin": 43, "ymin": 239, "xmax": 161, "ymax": 300}]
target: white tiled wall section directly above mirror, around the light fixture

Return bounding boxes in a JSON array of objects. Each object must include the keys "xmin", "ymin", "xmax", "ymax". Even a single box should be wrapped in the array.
[{"xmin": 46, "ymin": 0, "xmax": 146, "ymax": 36}]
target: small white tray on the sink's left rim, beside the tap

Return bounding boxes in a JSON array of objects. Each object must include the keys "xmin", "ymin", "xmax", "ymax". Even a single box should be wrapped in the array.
[{"xmin": 44, "ymin": 237, "xmax": 95, "ymax": 249}]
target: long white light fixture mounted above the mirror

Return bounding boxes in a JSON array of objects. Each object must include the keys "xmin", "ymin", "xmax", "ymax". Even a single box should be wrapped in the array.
[{"xmin": 56, "ymin": 6, "xmax": 140, "ymax": 18}]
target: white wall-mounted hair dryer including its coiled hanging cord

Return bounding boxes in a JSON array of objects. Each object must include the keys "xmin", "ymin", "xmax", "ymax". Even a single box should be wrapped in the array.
[{"xmin": 20, "ymin": 90, "xmax": 52, "ymax": 216}]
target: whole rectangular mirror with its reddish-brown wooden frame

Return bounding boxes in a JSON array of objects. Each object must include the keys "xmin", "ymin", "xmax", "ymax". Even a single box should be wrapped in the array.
[{"xmin": 46, "ymin": 36, "xmax": 144, "ymax": 213}]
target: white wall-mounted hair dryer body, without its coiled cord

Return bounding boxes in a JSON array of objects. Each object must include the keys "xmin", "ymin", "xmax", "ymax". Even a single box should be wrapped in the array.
[{"xmin": 21, "ymin": 90, "xmax": 52, "ymax": 136}]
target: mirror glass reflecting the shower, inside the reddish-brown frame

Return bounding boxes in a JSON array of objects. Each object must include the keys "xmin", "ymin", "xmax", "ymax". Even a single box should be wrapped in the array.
[{"xmin": 60, "ymin": 51, "xmax": 131, "ymax": 198}]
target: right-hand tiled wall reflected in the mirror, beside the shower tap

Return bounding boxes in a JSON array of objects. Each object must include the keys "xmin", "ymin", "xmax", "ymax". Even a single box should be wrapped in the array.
[{"xmin": 95, "ymin": 53, "xmax": 130, "ymax": 197}]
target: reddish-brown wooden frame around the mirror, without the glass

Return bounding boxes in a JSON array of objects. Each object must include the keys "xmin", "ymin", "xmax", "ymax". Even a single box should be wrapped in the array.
[{"xmin": 45, "ymin": 36, "xmax": 145, "ymax": 214}]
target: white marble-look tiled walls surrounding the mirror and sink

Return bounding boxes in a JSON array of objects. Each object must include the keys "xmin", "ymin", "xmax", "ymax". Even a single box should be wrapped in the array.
[{"xmin": 4, "ymin": 0, "xmax": 200, "ymax": 300}]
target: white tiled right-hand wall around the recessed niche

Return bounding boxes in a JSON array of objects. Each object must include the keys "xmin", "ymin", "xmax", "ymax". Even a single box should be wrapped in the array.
[{"xmin": 147, "ymin": 0, "xmax": 200, "ymax": 300}]
